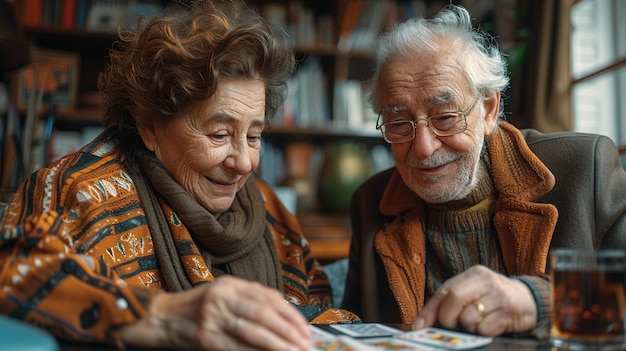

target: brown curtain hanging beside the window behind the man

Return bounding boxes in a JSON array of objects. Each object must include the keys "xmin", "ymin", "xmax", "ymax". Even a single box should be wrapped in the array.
[{"xmin": 510, "ymin": 0, "xmax": 576, "ymax": 132}]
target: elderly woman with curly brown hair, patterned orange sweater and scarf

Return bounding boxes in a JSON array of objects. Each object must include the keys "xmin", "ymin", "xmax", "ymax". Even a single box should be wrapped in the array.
[{"xmin": 0, "ymin": 1, "xmax": 354, "ymax": 350}]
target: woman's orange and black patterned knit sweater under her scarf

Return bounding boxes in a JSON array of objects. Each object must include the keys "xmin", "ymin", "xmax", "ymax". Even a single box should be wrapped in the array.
[{"xmin": 0, "ymin": 133, "xmax": 352, "ymax": 342}]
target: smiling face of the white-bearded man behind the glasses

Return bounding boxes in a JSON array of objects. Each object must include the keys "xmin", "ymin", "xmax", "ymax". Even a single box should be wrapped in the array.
[{"xmin": 378, "ymin": 50, "xmax": 499, "ymax": 203}]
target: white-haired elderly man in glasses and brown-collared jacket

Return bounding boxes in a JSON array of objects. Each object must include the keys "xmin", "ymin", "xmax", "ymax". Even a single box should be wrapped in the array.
[{"xmin": 343, "ymin": 2, "xmax": 626, "ymax": 337}]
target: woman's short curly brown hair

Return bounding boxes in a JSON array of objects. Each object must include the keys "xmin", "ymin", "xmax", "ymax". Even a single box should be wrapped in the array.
[{"xmin": 98, "ymin": 0, "xmax": 295, "ymax": 162}]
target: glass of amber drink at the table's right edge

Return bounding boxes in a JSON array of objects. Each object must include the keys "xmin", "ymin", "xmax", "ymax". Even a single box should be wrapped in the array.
[{"xmin": 551, "ymin": 249, "xmax": 626, "ymax": 349}]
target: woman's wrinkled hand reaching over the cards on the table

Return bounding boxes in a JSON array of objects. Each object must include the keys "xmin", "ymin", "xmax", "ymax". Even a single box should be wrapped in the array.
[{"xmin": 120, "ymin": 276, "xmax": 311, "ymax": 350}]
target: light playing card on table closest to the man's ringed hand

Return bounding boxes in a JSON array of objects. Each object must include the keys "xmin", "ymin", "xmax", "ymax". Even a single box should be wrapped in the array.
[{"xmin": 396, "ymin": 328, "xmax": 493, "ymax": 350}]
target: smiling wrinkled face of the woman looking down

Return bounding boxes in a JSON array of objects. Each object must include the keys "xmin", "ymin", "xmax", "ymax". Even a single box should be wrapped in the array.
[{"xmin": 139, "ymin": 78, "xmax": 265, "ymax": 215}]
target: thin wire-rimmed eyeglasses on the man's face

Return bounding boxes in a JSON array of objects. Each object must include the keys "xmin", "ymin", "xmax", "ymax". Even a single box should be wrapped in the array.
[{"xmin": 376, "ymin": 97, "xmax": 480, "ymax": 144}]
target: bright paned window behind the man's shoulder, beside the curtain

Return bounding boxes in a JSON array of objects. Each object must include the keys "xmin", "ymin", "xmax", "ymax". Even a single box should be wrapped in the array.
[{"xmin": 571, "ymin": 0, "xmax": 626, "ymax": 145}]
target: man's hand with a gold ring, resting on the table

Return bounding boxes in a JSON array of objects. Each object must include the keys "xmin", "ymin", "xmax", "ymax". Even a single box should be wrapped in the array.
[{"xmin": 412, "ymin": 266, "xmax": 537, "ymax": 336}]
